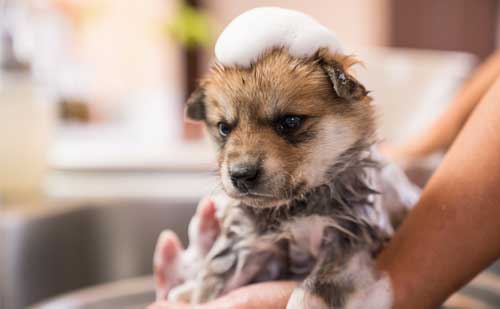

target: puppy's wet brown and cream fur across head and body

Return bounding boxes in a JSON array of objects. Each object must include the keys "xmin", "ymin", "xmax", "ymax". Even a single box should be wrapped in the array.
[{"xmin": 168, "ymin": 48, "xmax": 416, "ymax": 308}]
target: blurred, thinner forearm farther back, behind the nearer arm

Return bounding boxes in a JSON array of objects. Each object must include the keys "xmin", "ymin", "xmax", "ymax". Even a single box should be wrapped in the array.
[{"xmin": 393, "ymin": 51, "xmax": 500, "ymax": 160}]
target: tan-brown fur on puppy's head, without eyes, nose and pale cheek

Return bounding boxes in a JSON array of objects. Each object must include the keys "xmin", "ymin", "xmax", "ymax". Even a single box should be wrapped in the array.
[{"xmin": 188, "ymin": 49, "xmax": 374, "ymax": 206}]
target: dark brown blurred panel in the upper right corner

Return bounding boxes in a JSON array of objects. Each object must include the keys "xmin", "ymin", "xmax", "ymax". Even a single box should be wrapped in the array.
[{"xmin": 389, "ymin": 0, "xmax": 500, "ymax": 58}]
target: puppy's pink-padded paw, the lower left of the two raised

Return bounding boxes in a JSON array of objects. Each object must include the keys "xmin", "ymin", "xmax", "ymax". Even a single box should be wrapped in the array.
[{"xmin": 153, "ymin": 230, "xmax": 183, "ymax": 300}]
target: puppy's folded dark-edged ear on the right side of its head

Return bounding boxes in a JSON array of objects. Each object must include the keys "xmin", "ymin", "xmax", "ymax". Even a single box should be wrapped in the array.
[{"xmin": 319, "ymin": 53, "xmax": 368, "ymax": 101}]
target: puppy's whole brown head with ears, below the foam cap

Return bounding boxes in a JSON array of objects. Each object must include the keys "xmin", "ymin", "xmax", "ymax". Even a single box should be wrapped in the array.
[{"xmin": 186, "ymin": 49, "xmax": 374, "ymax": 207}]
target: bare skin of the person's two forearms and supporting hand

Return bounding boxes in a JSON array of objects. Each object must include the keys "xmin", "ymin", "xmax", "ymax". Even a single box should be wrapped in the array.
[{"xmin": 152, "ymin": 53, "xmax": 500, "ymax": 309}]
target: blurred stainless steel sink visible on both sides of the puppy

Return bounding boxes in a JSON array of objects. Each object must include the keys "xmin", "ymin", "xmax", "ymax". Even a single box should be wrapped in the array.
[{"xmin": 4, "ymin": 196, "xmax": 500, "ymax": 309}]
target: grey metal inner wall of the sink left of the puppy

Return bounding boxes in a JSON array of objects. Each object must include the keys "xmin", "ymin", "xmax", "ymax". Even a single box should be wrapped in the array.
[{"xmin": 0, "ymin": 200, "xmax": 196, "ymax": 309}]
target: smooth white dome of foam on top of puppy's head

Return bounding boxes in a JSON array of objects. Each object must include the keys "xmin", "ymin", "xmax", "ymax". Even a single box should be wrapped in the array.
[{"xmin": 215, "ymin": 7, "xmax": 342, "ymax": 67}]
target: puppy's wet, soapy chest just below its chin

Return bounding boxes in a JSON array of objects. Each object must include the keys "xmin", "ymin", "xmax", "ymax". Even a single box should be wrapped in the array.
[{"xmin": 207, "ymin": 197, "xmax": 386, "ymax": 281}]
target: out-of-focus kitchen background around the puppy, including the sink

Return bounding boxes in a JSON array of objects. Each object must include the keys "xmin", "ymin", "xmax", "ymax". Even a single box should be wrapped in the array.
[{"xmin": 0, "ymin": 0, "xmax": 500, "ymax": 309}]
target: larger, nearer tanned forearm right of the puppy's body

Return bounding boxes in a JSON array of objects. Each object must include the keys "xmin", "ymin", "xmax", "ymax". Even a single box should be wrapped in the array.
[{"xmin": 377, "ymin": 76, "xmax": 500, "ymax": 308}]
